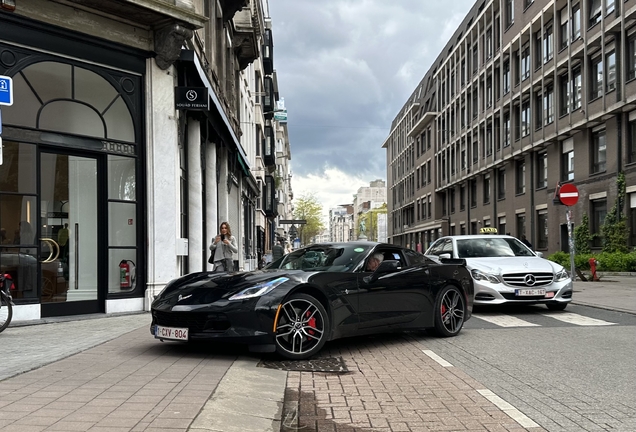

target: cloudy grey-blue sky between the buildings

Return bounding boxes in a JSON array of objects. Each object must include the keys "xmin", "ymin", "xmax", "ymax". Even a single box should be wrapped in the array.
[{"xmin": 269, "ymin": 0, "xmax": 475, "ymax": 213}]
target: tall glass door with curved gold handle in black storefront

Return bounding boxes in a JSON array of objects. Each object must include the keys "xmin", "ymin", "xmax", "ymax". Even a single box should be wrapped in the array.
[{"xmin": 40, "ymin": 152, "xmax": 100, "ymax": 316}]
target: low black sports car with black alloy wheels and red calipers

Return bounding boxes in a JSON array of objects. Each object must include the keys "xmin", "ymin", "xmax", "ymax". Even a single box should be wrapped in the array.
[{"xmin": 150, "ymin": 241, "xmax": 473, "ymax": 359}]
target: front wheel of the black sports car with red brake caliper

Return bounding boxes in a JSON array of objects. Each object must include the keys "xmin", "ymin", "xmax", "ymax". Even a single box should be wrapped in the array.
[{"xmin": 276, "ymin": 294, "xmax": 330, "ymax": 360}]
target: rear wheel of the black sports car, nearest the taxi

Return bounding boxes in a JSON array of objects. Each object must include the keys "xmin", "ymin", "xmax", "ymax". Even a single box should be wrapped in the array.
[{"xmin": 433, "ymin": 285, "xmax": 466, "ymax": 337}]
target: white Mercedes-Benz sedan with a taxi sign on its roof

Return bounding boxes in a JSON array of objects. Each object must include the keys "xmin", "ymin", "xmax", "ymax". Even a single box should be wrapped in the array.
[{"xmin": 424, "ymin": 234, "xmax": 573, "ymax": 310}]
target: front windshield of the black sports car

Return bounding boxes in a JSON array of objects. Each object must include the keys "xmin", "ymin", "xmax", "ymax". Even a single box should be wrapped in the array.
[{"xmin": 267, "ymin": 245, "xmax": 371, "ymax": 272}]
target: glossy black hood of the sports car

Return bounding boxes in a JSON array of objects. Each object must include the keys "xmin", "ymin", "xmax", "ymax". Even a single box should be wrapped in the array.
[{"xmin": 152, "ymin": 270, "xmax": 306, "ymax": 310}]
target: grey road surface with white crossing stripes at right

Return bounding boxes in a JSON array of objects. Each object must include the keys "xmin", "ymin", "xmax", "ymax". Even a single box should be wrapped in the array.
[{"xmin": 422, "ymin": 305, "xmax": 636, "ymax": 432}]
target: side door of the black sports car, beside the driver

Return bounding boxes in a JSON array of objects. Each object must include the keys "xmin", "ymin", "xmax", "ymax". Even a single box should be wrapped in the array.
[{"xmin": 358, "ymin": 248, "xmax": 429, "ymax": 330}]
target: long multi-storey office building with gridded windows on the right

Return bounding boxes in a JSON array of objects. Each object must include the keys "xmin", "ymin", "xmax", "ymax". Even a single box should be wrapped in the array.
[{"xmin": 383, "ymin": 0, "xmax": 636, "ymax": 254}]
